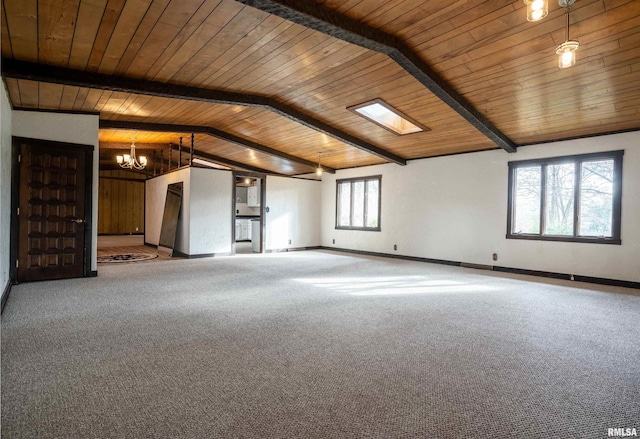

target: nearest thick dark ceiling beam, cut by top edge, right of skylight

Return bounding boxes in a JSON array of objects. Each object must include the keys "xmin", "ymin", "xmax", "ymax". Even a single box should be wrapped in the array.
[{"xmin": 236, "ymin": 0, "xmax": 518, "ymax": 152}]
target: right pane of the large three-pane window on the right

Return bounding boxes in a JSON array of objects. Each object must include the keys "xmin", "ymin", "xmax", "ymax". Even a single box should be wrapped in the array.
[{"xmin": 579, "ymin": 159, "xmax": 613, "ymax": 237}]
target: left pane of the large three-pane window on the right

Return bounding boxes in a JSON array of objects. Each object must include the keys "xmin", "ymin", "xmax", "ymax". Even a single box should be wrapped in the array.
[{"xmin": 512, "ymin": 166, "xmax": 541, "ymax": 233}]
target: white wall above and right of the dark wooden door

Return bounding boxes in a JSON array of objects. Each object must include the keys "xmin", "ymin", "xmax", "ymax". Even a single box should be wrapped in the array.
[{"xmin": 12, "ymin": 111, "xmax": 100, "ymax": 271}]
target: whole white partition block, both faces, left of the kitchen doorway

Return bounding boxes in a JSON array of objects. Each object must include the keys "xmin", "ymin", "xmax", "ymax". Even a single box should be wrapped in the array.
[{"xmin": 145, "ymin": 167, "xmax": 233, "ymax": 256}]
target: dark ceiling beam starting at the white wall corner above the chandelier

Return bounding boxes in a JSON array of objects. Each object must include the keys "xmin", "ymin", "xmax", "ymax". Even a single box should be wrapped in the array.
[{"xmin": 100, "ymin": 120, "xmax": 336, "ymax": 174}]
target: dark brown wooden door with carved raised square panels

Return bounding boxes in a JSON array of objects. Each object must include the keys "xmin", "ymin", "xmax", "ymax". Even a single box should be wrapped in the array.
[{"xmin": 17, "ymin": 139, "xmax": 91, "ymax": 281}]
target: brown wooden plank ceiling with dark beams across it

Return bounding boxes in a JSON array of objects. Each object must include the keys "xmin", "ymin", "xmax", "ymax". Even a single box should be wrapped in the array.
[{"xmin": 2, "ymin": 0, "xmax": 640, "ymax": 175}]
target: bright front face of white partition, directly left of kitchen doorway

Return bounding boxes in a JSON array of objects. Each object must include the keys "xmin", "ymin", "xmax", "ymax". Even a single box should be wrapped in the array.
[{"xmin": 189, "ymin": 168, "xmax": 235, "ymax": 255}]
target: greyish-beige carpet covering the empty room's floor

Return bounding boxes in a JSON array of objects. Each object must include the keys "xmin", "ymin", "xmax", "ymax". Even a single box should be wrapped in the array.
[{"xmin": 1, "ymin": 251, "xmax": 640, "ymax": 439}]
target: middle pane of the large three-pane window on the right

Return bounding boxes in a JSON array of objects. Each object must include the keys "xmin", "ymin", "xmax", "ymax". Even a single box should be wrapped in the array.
[{"xmin": 544, "ymin": 163, "xmax": 576, "ymax": 235}]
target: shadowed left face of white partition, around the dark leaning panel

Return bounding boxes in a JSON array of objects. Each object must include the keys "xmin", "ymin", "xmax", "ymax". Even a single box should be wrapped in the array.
[{"xmin": 144, "ymin": 168, "xmax": 192, "ymax": 255}]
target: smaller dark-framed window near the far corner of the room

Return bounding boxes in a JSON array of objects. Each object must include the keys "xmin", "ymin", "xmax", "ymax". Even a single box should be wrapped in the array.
[{"xmin": 336, "ymin": 175, "xmax": 382, "ymax": 231}]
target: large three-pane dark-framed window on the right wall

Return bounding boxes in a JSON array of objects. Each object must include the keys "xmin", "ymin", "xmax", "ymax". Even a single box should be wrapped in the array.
[{"xmin": 507, "ymin": 151, "xmax": 624, "ymax": 244}]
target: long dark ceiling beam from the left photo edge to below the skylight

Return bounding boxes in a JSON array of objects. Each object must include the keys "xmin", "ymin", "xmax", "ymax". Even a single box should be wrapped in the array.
[{"xmin": 2, "ymin": 58, "xmax": 407, "ymax": 165}]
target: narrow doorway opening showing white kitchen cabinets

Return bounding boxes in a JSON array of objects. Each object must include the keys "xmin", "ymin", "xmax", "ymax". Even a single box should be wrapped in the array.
[{"xmin": 231, "ymin": 172, "xmax": 266, "ymax": 255}]
